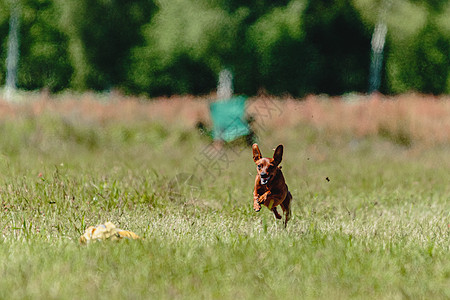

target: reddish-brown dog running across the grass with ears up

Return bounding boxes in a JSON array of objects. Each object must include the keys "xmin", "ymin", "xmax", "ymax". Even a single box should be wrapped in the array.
[{"xmin": 252, "ymin": 144, "xmax": 292, "ymax": 227}]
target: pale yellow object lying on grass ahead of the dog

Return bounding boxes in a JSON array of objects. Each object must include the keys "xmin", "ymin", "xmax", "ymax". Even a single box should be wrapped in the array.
[{"xmin": 79, "ymin": 222, "xmax": 140, "ymax": 244}]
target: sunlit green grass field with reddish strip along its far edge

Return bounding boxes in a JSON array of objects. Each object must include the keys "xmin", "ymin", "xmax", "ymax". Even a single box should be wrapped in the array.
[{"xmin": 0, "ymin": 95, "xmax": 450, "ymax": 299}]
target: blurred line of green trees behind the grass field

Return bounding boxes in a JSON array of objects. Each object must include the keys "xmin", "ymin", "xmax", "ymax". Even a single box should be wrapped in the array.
[{"xmin": 0, "ymin": 0, "xmax": 450, "ymax": 96}]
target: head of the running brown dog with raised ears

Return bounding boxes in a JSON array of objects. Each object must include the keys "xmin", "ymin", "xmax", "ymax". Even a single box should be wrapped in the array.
[{"xmin": 252, "ymin": 144, "xmax": 283, "ymax": 185}]
